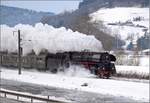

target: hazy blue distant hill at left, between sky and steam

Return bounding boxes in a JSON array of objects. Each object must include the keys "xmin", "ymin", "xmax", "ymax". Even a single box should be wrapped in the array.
[{"xmin": 0, "ymin": 5, "xmax": 54, "ymax": 26}]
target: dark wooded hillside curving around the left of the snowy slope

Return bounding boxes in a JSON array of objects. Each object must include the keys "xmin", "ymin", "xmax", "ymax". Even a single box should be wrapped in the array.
[{"xmin": 41, "ymin": 0, "xmax": 149, "ymax": 50}]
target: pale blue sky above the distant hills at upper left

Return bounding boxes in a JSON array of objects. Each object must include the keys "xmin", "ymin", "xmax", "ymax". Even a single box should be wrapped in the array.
[{"xmin": 1, "ymin": 0, "xmax": 82, "ymax": 14}]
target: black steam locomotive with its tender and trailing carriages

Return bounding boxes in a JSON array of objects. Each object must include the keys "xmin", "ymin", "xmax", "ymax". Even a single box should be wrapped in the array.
[{"xmin": 0, "ymin": 51, "xmax": 116, "ymax": 78}]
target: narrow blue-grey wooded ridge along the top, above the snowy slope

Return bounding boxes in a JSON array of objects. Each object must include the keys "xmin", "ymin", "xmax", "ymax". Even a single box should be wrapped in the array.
[{"xmin": 79, "ymin": 0, "xmax": 149, "ymax": 9}]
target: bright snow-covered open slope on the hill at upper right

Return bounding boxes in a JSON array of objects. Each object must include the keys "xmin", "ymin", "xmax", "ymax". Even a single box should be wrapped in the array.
[{"xmin": 90, "ymin": 7, "xmax": 149, "ymax": 48}]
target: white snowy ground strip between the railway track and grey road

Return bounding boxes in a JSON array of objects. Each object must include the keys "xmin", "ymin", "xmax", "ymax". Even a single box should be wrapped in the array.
[{"xmin": 1, "ymin": 68, "xmax": 149, "ymax": 102}]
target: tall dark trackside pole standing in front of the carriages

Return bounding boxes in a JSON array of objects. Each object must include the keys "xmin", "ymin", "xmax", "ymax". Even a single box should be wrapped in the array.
[{"xmin": 18, "ymin": 30, "xmax": 22, "ymax": 75}]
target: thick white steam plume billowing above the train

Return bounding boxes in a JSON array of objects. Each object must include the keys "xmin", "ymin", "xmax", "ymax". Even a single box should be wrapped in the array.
[{"xmin": 1, "ymin": 23, "xmax": 103, "ymax": 54}]
